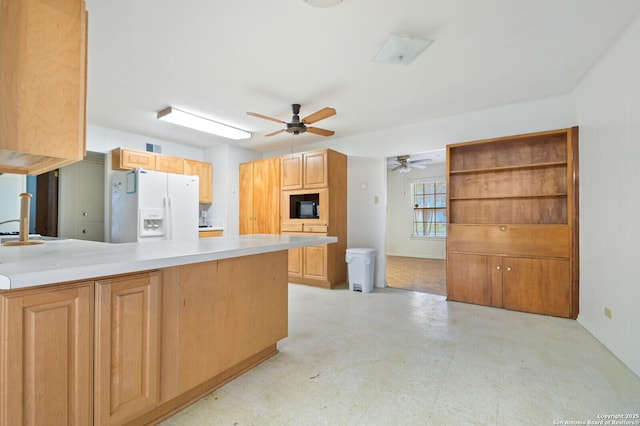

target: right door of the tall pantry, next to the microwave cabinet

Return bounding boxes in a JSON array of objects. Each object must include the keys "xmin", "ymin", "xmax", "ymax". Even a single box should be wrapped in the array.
[{"xmin": 253, "ymin": 157, "xmax": 281, "ymax": 234}]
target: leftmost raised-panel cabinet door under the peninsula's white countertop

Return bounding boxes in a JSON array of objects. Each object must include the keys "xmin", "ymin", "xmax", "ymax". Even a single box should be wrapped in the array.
[{"xmin": 0, "ymin": 283, "xmax": 93, "ymax": 425}]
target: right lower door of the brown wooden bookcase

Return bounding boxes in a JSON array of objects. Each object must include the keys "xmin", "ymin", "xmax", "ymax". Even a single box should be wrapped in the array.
[{"xmin": 503, "ymin": 257, "xmax": 571, "ymax": 317}]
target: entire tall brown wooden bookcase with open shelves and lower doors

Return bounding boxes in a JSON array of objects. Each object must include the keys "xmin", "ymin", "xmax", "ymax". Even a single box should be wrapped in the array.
[{"xmin": 447, "ymin": 127, "xmax": 579, "ymax": 318}]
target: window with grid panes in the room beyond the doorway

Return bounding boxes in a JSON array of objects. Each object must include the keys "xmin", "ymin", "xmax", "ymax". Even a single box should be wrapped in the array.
[{"xmin": 411, "ymin": 178, "xmax": 447, "ymax": 238}]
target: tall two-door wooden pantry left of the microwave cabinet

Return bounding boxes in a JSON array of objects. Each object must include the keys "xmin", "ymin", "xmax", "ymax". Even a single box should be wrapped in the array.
[{"xmin": 239, "ymin": 157, "xmax": 280, "ymax": 235}]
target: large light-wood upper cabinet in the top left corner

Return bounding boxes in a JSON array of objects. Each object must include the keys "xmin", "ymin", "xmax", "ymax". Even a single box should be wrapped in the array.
[{"xmin": 0, "ymin": 0, "xmax": 87, "ymax": 175}]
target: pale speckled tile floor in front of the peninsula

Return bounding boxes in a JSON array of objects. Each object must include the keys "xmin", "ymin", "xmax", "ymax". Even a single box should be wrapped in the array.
[{"xmin": 163, "ymin": 284, "xmax": 640, "ymax": 426}]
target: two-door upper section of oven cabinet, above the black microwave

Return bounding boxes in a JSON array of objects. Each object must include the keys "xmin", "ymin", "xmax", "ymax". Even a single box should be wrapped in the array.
[{"xmin": 282, "ymin": 149, "xmax": 343, "ymax": 191}]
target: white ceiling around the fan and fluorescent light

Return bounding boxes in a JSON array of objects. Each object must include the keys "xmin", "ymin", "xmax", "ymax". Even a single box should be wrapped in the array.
[{"xmin": 87, "ymin": 0, "xmax": 640, "ymax": 152}]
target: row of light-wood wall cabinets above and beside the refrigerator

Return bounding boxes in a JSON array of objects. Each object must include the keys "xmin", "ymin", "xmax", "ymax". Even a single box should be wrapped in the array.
[{"xmin": 111, "ymin": 148, "xmax": 213, "ymax": 204}]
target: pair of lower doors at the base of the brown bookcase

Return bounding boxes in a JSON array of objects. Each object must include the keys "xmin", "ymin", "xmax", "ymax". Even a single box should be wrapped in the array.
[{"xmin": 447, "ymin": 253, "xmax": 571, "ymax": 317}]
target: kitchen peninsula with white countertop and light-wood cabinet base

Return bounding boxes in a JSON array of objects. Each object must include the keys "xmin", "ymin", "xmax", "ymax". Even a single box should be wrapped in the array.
[{"xmin": 0, "ymin": 235, "xmax": 337, "ymax": 426}]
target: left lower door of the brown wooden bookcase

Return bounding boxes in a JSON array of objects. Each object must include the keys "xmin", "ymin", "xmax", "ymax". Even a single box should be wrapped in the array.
[{"xmin": 447, "ymin": 253, "xmax": 502, "ymax": 307}]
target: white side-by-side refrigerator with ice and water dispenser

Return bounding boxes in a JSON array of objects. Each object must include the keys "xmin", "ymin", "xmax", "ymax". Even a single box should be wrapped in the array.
[{"xmin": 111, "ymin": 169, "xmax": 199, "ymax": 243}]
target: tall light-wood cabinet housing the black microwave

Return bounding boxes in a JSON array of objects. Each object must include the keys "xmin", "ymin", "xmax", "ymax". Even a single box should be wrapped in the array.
[{"xmin": 281, "ymin": 149, "xmax": 347, "ymax": 288}]
